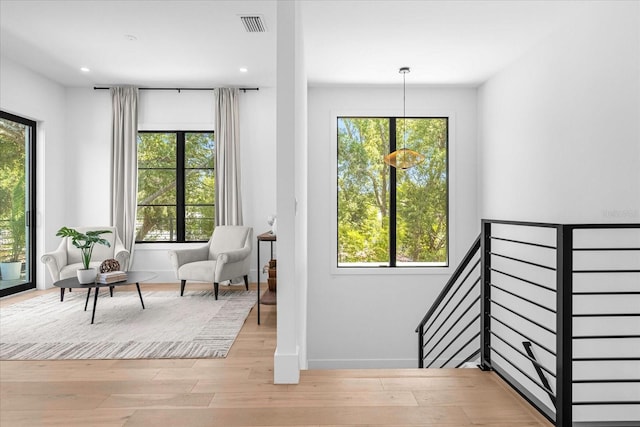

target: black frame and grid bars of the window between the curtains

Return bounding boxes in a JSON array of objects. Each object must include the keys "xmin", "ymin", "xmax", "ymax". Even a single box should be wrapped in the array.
[{"xmin": 136, "ymin": 130, "xmax": 217, "ymax": 244}]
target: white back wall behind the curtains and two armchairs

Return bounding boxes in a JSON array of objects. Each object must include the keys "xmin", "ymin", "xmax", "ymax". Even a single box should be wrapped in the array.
[{"xmin": 65, "ymin": 88, "xmax": 275, "ymax": 283}]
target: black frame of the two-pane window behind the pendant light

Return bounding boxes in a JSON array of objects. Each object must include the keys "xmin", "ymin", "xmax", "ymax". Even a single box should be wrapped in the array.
[{"xmin": 335, "ymin": 115, "xmax": 451, "ymax": 269}]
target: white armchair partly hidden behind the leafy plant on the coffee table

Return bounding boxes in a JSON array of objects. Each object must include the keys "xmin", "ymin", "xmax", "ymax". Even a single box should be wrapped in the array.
[{"xmin": 40, "ymin": 226, "xmax": 130, "ymax": 282}]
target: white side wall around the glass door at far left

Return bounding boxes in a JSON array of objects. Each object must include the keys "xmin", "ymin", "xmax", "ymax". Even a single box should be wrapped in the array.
[{"xmin": 0, "ymin": 57, "xmax": 67, "ymax": 289}]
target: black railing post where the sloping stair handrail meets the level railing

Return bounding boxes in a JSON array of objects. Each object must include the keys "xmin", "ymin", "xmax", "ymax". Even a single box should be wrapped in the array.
[{"xmin": 480, "ymin": 219, "xmax": 492, "ymax": 371}]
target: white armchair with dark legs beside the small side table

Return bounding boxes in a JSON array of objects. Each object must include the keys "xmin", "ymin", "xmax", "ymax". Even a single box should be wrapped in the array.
[{"xmin": 169, "ymin": 225, "xmax": 253, "ymax": 300}]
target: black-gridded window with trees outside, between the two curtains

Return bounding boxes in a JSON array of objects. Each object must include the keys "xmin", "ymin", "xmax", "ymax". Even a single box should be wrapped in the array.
[{"xmin": 136, "ymin": 131, "xmax": 215, "ymax": 242}]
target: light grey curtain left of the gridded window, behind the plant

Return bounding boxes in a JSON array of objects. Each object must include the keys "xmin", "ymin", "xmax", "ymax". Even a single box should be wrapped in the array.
[{"xmin": 110, "ymin": 87, "xmax": 138, "ymax": 269}]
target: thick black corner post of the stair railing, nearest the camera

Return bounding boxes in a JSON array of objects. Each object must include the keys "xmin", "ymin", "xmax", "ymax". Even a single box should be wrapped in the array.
[{"xmin": 556, "ymin": 225, "xmax": 573, "ymax": 426}]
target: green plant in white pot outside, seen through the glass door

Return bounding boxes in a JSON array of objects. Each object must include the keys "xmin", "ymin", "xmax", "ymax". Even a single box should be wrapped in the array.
[{"xmin": 0, "ymin": 178, "xmax": 26, "ymax": 280}]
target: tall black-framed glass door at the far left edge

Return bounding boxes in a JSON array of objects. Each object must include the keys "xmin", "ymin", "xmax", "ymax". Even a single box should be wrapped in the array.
[{"xmin": 0, "ymin": 111, "xmax": 36, "ymax": 296}]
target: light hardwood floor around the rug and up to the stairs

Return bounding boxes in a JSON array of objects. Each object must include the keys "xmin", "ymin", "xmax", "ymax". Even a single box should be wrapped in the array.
[{"xmin": 0, "ymin": 284, "xmax": 551, "ymax": 427}]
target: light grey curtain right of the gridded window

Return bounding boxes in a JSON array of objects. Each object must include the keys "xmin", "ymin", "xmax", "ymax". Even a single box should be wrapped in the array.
[{"xmin": 214, "ymin": 88, "xmax": 242, "ymax": 225}]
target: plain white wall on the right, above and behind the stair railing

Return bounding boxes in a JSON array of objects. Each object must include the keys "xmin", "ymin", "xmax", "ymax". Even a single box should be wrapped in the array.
[{"xmin": 478, "ymin": 2, "xmax": 640, "ymax": 421}]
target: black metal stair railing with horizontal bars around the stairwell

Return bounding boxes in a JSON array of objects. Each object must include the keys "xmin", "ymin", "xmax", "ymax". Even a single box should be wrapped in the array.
[{"xmin": 416, "ymin": 220, "xmax": 640, "ymax": 426}]
